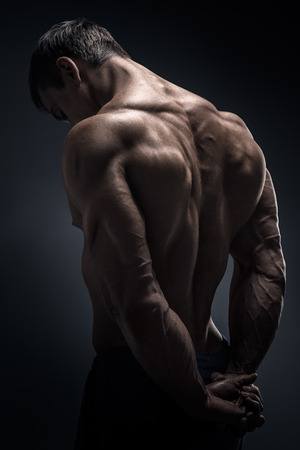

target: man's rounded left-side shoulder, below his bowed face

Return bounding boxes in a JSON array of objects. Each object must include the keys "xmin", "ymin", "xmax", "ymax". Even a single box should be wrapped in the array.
[{"xmin": 62, "ymin": 112, "xmax": 145, "ymax": 203}]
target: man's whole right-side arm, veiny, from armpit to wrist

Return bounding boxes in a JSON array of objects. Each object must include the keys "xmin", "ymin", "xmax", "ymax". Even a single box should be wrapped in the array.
[{"xmin": 227, "ymin": 171, "xmax": 285, "ymax": 373}]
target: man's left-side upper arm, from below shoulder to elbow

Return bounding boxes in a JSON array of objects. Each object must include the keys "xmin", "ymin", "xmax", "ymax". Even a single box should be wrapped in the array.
[{"xmin": 61, "ymin": 118, "xmax": 161, "ymax": 320}]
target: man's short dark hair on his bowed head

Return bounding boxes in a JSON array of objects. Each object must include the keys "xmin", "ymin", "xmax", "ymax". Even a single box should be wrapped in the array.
[{"xmin": 28, "ymin": 18, "xmax": 130, "ymax": 111}]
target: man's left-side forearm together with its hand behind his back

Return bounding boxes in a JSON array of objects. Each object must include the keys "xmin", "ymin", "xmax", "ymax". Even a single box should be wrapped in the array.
[{"xmin": 103, "ymin": 274, "xmax": 255, "ymax": 425}]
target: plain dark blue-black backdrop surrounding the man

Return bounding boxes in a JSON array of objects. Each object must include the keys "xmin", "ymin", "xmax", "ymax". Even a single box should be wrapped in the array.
[{"xmin": 0, "ymin": 1, "xmax": 300, "ymax": 450}]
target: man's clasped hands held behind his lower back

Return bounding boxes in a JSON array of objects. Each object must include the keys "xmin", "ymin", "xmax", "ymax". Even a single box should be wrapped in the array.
[{"xmin": 206, "ymin": 372, "xmax": 265, "ymax": 437}]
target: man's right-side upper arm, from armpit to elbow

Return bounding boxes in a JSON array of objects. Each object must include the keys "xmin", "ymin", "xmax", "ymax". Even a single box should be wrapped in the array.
[{"xmin": 231, "ymin": 171, "xmax": 285, "ymax": 281}]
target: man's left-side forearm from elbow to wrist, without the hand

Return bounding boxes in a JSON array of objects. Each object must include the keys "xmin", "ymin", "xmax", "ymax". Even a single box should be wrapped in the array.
[{"xmin": 101, "ymin": 268, "xmax": 207, "ymax": 417}]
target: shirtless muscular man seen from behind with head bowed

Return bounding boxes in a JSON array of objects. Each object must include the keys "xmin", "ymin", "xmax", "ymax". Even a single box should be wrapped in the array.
[{"xmin": 29, "ymin": 19, "xmax": 285, "ymax": 450}]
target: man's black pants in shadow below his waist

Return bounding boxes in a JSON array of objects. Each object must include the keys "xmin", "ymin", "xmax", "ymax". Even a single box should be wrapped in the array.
[{"xmin": 75, "ymin": 341, "xmax": 239, "ymax": 450}]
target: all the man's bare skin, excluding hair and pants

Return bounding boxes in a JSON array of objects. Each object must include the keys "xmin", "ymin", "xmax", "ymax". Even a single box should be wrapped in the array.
[{"xmin": 41, "ymin": 57, "xmax": 285, "ymax": 432}]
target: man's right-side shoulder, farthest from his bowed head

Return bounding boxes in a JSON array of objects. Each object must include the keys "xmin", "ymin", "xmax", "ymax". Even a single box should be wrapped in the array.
[{"xmin": 195, "ymin": 107, "xmax": 266, "ymax": 227}]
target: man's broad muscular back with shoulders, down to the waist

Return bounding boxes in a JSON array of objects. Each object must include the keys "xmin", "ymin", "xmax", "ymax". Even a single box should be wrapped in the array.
[{"xmin": 64, "ymin": 74, "xmax": 265, "ymax": 351}]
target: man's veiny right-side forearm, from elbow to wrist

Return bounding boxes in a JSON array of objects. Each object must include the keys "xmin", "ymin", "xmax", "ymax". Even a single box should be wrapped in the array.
[{"xmin": 227, "ymin": 269, "xmax": 285, "ymax": 373}]
